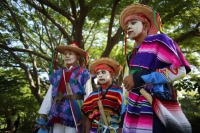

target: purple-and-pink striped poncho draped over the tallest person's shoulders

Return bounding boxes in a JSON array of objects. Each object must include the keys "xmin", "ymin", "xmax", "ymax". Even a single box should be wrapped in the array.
[{"xmin": 129, "ymin": 34, "xmax": 190, "ymax": 73}]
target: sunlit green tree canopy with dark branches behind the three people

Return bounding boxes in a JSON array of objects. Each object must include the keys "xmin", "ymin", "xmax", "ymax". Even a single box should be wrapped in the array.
[{"xmin": 0, "ymin": 0, "xmax": 200, "ymax": 131}]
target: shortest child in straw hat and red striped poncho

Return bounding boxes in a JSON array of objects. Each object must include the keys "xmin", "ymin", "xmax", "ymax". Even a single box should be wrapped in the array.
[{"xmin": 82, "ymin": 58, "xmax": 123, "ymax": 133}]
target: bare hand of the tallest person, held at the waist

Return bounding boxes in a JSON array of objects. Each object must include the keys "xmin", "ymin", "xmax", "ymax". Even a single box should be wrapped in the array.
[{"xmin": 123, "ymin": 75, "xmax": 135, "ymax": 91}]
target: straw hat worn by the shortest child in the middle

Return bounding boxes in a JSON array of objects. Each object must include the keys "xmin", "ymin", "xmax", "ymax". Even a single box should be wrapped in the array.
[{"xmin": 89, "ymin": 57, "xmax": 122, "ymax": 76}]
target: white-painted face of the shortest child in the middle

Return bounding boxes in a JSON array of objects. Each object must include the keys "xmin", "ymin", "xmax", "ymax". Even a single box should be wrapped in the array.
[{"xmin": 97, "ymin": 69, "xmax": 111, "ymax": 84}]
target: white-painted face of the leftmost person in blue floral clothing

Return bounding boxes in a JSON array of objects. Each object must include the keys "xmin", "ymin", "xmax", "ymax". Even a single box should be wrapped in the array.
[{"xmin": 64, "ymin": 50, "xmax": 77, "ymax": 65}]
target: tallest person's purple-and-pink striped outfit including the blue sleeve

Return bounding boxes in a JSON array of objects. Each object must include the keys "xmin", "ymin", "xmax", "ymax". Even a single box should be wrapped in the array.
[{"xmin": 123, "ymin": 34, "xmax": 190, "ymax": 133}]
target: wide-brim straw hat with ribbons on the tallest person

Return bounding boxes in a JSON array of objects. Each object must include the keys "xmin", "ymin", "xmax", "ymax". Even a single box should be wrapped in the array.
[{"xmin": 119, "ymin": 4, "xmax": 161, "ymax": 35}]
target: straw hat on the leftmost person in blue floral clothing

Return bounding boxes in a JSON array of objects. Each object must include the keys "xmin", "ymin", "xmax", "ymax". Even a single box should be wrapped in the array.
[{"xmin": 56, "ymin": 43, "xmax": 86, "ymax": 57}]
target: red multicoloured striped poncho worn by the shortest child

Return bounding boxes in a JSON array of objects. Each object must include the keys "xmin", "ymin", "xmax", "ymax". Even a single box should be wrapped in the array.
[{"xmin": 82, "ymin": 84, "xmax": 122, "ymax": 133}]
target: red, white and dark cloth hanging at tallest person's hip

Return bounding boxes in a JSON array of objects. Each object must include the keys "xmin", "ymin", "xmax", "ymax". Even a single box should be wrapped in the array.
[{"xmin": 152, "ymin": 97, "xmax": 192, "ymax": 133}]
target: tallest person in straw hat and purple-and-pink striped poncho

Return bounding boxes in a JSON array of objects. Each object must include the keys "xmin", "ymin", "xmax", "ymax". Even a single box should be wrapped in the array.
[{"xmin": 119, "ymin": 4, "xmax": 191, "ymax": 133}]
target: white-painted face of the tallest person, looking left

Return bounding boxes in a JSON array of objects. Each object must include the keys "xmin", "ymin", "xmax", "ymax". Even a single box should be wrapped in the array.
[{"xmin": 126, "ymin": 20, "xmax": 143, "ymax": 39}]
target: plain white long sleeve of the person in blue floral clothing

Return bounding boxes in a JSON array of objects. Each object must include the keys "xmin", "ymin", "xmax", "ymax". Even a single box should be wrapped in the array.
[{"xmin": 38, "ymin": 85, "xmax": 53, "ymax": 115}]
